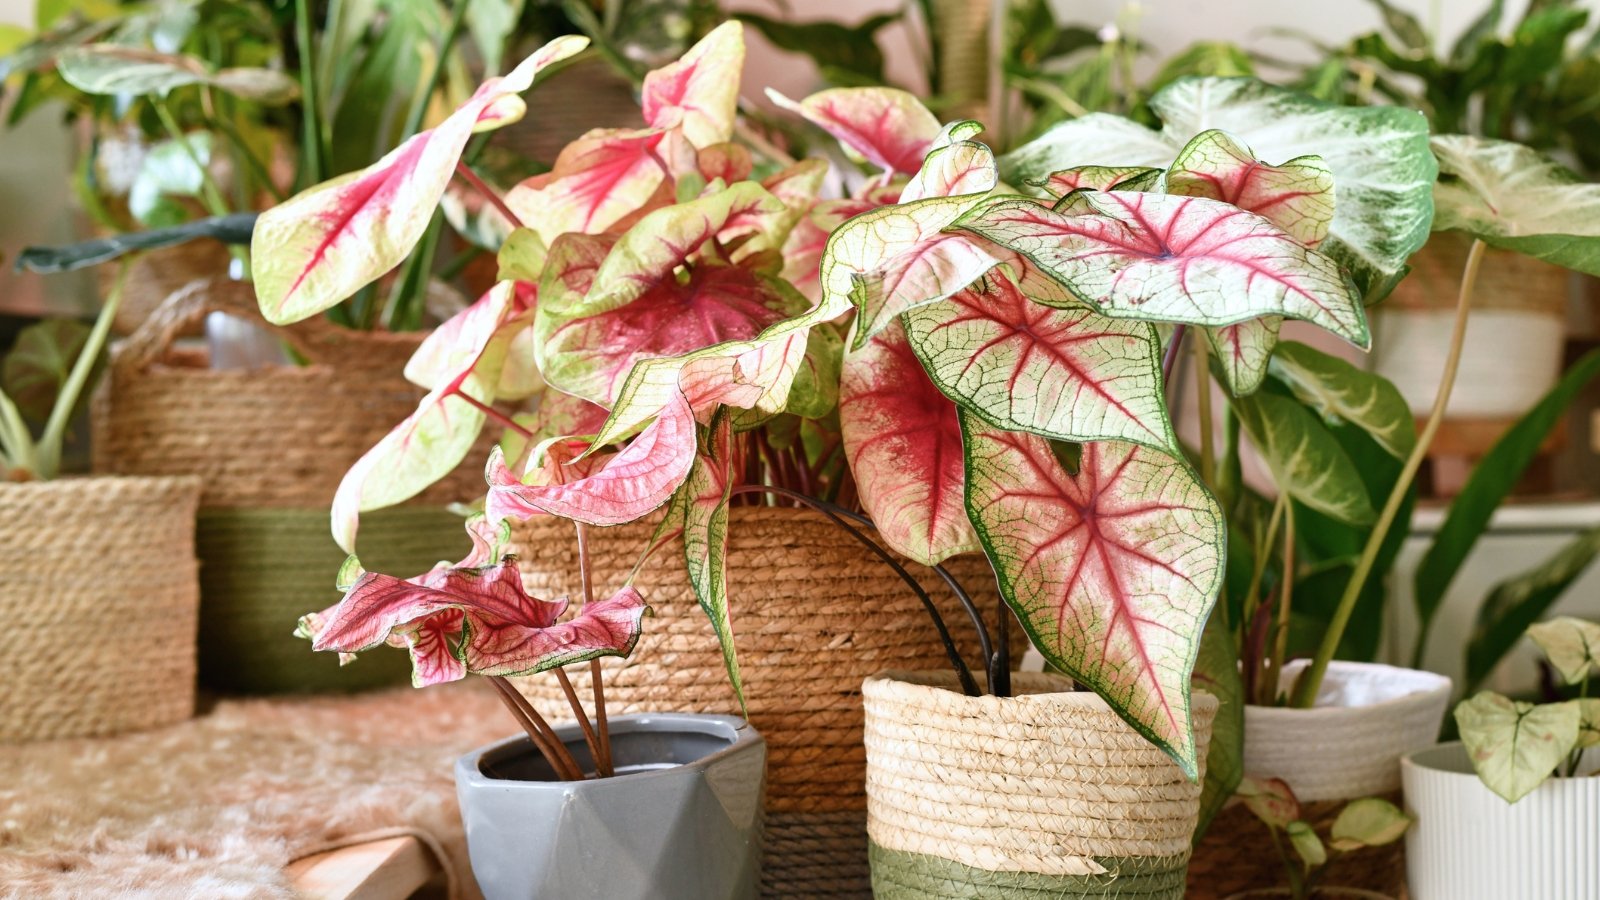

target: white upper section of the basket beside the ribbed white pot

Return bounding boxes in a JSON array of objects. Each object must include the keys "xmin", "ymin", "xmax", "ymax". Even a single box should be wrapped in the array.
[{"xmin": 1245, "ymin": 660, "xmax": 1450, "ymax": 802}]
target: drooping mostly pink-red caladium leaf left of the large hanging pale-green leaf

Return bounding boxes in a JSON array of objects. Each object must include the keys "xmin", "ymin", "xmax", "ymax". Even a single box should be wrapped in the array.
[{"xmin": 838, "ymin": 318, "xmax": 982, "ymax": 565}]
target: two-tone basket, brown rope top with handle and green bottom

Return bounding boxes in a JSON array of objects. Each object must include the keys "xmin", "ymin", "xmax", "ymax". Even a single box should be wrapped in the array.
[{"xmin": 93, "ymin": 277, "xmax": 490, "ymax": 693}]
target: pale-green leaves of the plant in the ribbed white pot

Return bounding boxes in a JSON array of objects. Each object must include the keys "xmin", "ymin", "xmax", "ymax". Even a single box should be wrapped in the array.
[{"xmin": 1456, "ymin": 617, "xmax": 1600, "ymax": 804}]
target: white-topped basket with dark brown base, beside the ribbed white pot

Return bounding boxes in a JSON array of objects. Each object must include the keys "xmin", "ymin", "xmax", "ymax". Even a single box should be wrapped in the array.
[{"xmin": 1189, "ymin": 660, "xmax": 1450, "ymax": 900}]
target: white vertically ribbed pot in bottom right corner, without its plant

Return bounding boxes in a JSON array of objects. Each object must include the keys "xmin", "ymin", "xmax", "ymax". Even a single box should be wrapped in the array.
[{"xmin": 1400, "ymin": 741, "xmax": 1600, "ymax": 900}]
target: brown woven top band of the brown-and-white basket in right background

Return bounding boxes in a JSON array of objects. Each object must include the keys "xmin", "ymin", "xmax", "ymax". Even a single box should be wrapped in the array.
[{"xmin": 1382, "ymin": 232, "xmax": 1571, "ymax": 320}]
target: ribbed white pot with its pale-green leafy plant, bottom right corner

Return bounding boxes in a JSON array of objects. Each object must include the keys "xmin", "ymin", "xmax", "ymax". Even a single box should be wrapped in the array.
[{"xmin": 1403, "ymin": 617, "xmax": 1600, "ymax": 900}]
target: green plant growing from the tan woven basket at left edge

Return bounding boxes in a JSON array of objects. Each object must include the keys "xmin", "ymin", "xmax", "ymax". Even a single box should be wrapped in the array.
[{"xmin": 0, "ymin": 265, "xmax": 122, "ymax": 482}]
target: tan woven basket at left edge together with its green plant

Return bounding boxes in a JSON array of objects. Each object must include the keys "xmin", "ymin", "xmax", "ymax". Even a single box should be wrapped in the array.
[{"xmin": 0, "ymin": 269, "xmax": 200, "ymax": 741}]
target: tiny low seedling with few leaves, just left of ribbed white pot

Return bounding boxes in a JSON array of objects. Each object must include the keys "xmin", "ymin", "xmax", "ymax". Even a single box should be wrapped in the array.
[{"xmin": 1238, "ymin": 777, "xmax": 1411, "ymax": 900}]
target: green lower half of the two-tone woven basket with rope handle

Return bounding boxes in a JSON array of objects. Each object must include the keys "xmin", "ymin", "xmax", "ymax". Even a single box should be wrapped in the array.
[{"xmin": 197, "ymin": 506, "xmax": 470, "ymax": 693}]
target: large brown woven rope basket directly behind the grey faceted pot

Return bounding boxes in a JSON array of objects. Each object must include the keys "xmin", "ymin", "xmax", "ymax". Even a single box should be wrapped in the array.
[{"xmin": 512, "ymin": 508, "xmax": 1004, "ymax": 897}]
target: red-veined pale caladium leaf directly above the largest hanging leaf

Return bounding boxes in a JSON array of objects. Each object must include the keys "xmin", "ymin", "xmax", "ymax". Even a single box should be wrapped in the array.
[{"xmin": 904, "ymin": 271, "xmax": 1178, "ymax": 453}]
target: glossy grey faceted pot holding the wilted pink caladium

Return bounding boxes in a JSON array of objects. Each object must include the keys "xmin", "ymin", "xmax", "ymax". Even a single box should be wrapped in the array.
[{"xmin": 456, "ymin": 713, "xmax": 766, "ymax": 900}]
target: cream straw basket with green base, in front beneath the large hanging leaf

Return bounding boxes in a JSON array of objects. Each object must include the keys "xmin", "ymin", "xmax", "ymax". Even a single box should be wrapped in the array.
[{"xmin": 862, "ymin": 673, "xmax": 1218, "ymax": 900}]
